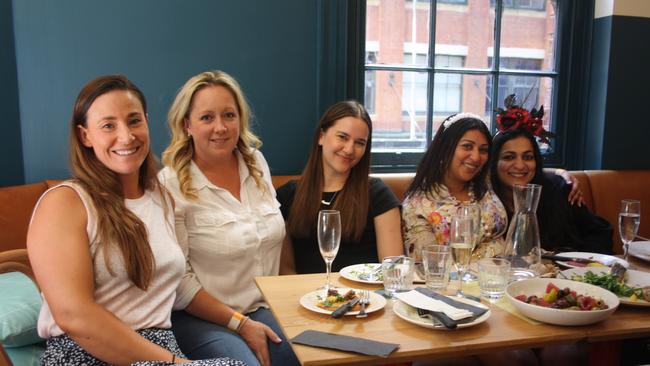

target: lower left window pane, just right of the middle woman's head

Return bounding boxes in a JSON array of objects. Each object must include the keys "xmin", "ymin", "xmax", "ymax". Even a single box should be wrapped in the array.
[{"xmin": 366, "ymin": 71, "xmax": 427, "ymax": 152}]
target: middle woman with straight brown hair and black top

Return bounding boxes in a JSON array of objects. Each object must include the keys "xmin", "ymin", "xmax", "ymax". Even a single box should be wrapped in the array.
[{"xmin": 278, "ymin": 101, "xmax": 403, "ymax": 274}]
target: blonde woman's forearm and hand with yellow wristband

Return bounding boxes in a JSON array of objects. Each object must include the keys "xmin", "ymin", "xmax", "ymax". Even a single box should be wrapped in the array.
[{"xmin": 185, "ymin": 289, "xmax": 282, "ymax": 366}]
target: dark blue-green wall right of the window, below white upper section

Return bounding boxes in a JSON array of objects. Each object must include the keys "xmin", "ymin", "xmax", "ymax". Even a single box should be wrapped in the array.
[{"xmin": 584, "ymin": 16, "xmax": 650, "ymax": 169}]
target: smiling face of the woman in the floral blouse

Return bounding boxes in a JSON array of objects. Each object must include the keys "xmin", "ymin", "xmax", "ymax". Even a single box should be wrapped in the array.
[{"xmin": 443, "ymin": 130, "xmax": 490, "ymax": 187}]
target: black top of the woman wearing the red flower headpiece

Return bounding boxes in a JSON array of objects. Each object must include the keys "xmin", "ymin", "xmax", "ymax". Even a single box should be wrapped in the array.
[{"xmin": 537, "ymin": 173, "xmax": 613, "ymax": 254}]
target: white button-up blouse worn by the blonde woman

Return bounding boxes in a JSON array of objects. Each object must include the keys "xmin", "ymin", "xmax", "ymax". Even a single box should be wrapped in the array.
[{"xmin": 158, "ymin": 151, "xmax": 285, "ymax": 313}]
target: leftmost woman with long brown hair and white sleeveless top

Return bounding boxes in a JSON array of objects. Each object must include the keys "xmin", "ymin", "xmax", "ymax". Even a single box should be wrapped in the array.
[{"xmin": 27, "ymin": 75, "xmax": 242, "ymax": 365}]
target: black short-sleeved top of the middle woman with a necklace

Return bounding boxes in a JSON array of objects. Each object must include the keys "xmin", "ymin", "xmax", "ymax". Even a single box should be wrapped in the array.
[{"xmin": 277, "ymin": 178, "xmax": 400, "ymax": 273}]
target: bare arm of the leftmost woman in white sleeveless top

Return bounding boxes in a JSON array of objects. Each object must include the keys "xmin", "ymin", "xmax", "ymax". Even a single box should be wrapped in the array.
[{"xmin": 27, "ymin": 188, "xmax": 186, "ymax": 364}]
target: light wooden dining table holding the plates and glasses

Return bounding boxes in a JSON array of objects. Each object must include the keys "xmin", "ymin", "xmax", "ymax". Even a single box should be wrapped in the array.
[{"xmin": 255, "ymin": 260, "xmax": 650, "ymax": 365}]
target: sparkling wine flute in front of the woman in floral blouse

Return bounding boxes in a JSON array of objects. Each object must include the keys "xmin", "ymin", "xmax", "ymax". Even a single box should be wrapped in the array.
[{"xmin": 449, "ymin": 216, "xmax": 474, "ymax": 297}]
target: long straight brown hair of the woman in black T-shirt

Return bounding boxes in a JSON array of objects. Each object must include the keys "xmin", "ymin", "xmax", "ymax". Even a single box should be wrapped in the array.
[{"xmin": 287, "ymin": 100, "xmax": 372, "ymax": 241}]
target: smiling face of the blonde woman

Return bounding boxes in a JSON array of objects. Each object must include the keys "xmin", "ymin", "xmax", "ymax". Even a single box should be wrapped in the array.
[{"xmin": 185, "ymin": 86, "xmax": 240, "ymax": 164}]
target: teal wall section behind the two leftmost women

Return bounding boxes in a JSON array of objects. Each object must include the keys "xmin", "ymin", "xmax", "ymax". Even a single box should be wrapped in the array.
[{"xmin": 10, "ymin": 0, "xmax": 323, "ymax": 182}]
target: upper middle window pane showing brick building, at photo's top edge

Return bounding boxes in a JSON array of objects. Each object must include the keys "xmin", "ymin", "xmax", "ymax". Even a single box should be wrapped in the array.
[{"xmin": 436, "ymin": 0, "xmax": 494, "ymax": 68}]
